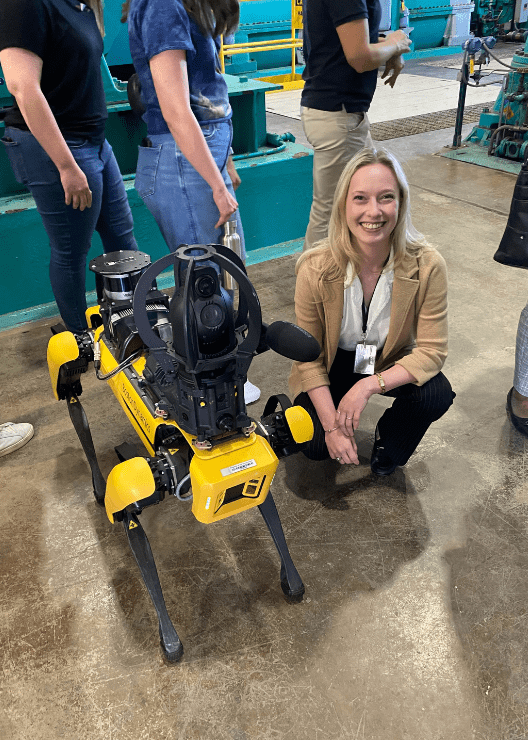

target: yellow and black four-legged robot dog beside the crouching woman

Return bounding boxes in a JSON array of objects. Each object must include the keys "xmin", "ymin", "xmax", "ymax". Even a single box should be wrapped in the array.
[{"xmin": 48, "ymin": 245, "xmax": 320, "ymax": 662}]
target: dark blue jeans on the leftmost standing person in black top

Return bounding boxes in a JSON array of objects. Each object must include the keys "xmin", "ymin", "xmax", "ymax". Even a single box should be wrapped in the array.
[{"xmin": 2, "ymin": 127, "xmax": 137, "ymax": 332}]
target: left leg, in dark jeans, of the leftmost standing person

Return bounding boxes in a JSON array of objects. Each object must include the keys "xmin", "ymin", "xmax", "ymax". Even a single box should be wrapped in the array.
[{"xmin": 2, "ymin": 128, "xmax": 102, "ymax": 333}]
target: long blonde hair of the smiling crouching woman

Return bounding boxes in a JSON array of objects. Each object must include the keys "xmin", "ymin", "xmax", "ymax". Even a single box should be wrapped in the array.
[{"xmin": 295, "ymin": 148, "xmax": 429, "ymax": 282}]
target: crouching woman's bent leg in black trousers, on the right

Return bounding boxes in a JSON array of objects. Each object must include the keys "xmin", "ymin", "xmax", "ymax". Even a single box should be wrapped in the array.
[{"xmin": 377, "ymin": 373, "xmax": 455, "ymax": 466}]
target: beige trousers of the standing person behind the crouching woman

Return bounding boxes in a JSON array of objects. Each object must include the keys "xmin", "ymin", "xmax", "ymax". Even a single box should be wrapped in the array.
[{"xmin": 301, "ymin": 106, "xmax": 373, "ymax": 249}]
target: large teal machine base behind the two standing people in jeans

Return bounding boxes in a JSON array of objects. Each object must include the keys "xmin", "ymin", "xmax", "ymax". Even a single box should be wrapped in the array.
[{"xmin": 0, "ymin": 0, "xmax": 312, "ymax": 329}]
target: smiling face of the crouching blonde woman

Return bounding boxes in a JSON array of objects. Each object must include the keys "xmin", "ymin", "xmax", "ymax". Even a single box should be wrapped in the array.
[{"xmin": 346, "ymin": 164, "xmax": 399, "ymax": 256}]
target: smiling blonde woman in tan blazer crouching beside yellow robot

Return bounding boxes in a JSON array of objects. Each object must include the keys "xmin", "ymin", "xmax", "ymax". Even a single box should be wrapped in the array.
[{"xmin": 290, "ymin": 149, "xmax": 455, "ymax": 475}]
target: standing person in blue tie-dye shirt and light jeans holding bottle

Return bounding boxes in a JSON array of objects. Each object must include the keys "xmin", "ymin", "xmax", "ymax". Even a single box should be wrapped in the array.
[{"xmin": 122, "ymin": 0, "xmax": 260, "ymax": 403}]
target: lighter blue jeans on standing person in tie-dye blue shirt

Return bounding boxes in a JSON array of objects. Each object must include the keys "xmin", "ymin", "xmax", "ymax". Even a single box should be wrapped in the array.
[{"xmin": 136, "ymin": 121, "xmax": 246, "ymax": 259}]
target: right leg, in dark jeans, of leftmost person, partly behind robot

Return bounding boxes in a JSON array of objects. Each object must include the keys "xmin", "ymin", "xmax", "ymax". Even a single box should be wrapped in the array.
[{"xmin": 95, "ymin": 141, "xmax": 138, "ymax": 252}]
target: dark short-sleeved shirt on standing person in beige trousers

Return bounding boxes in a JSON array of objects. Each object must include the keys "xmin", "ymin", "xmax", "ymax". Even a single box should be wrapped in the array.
[{"xmin": 301, "ymin": 0, "xmax": 381, "ymax": 113}]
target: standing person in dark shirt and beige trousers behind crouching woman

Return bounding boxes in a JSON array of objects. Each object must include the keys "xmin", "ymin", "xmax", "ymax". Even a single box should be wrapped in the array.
[{"xmin": 301, "ymin": 0, "xmax": 410, "ymax": 249}]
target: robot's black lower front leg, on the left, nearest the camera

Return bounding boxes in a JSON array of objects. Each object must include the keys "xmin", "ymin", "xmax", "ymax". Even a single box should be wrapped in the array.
[{"xmin": 123, "ymin": 510, "xmax": 183, "ymax": 663}]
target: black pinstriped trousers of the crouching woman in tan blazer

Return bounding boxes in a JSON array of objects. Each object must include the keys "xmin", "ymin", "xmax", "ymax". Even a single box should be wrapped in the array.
[{"xmin": 295, "ymin": 349, "xmax": 456, "ymax": 465}]
